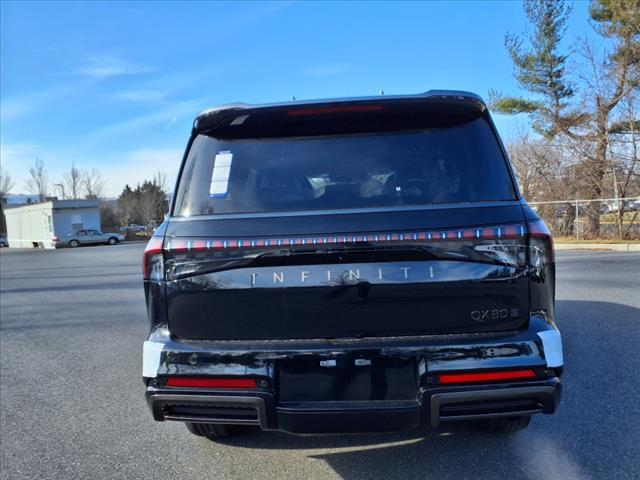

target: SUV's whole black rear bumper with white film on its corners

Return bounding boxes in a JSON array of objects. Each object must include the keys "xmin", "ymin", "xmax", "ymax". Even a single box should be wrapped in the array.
[{"xmin": 145, "ymin": 316, "xmax": 562, "ymax": 434}]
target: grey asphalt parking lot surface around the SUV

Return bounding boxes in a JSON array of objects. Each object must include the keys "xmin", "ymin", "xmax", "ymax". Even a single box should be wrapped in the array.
[{"xmin": 0, "ymin": 244, "xmax": 640, "ymax": 480}]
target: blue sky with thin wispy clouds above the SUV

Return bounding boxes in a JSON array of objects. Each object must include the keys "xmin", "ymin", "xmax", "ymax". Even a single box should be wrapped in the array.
[{"xmin": 0, "ymin": 1, "xmax": 593, "ymax": 196}]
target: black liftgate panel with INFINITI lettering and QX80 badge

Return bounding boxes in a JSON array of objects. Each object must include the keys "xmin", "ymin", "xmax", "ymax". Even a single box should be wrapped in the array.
[{"xmin": 159, "ymin": 222, "xmax": 529, "ymax": 340}]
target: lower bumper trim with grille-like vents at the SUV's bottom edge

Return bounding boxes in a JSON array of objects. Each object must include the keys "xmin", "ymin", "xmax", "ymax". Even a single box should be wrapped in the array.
[{"xmin": 147, "ymin": 378, "xmax": 561, "ymax": 434}]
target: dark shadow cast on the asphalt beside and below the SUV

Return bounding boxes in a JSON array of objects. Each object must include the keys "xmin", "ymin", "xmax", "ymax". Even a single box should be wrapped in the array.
[{"xmin": 198, "ymin": 300, "xmax": 640, "ymax": 480}]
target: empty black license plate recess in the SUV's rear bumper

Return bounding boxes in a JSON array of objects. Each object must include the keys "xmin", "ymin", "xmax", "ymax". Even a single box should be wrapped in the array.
[{"xmin": 278, "ymin": 357, "xmax": 418, "ymax": 402}]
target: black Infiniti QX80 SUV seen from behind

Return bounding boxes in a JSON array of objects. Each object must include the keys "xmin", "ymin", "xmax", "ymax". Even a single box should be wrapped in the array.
[{"xmin": 143, "ymin": 91, "xmax": 563, "ymax": 439}]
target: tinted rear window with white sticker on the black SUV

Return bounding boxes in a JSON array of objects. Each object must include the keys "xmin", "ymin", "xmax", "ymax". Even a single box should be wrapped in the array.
[{"xmin": 174, "ymin": 118, "xmax": 515, "ymax": 216}]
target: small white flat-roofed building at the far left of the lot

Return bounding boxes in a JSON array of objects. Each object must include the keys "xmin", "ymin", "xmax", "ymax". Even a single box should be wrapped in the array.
[{"xmin": 4, "ymin": 200, "xmax": 100, "ymax": 248}]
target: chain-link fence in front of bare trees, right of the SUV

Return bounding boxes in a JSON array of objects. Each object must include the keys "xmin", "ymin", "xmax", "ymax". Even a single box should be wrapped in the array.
[{"xmin": 528, "ymin": 197, "xmax": 640, "ymax": 240}]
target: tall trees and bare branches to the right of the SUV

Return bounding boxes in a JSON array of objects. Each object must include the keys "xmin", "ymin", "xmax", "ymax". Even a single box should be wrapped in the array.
[{"xmin": 490, "ymin": 0, "xmax": 640, "ymax": 238}]
